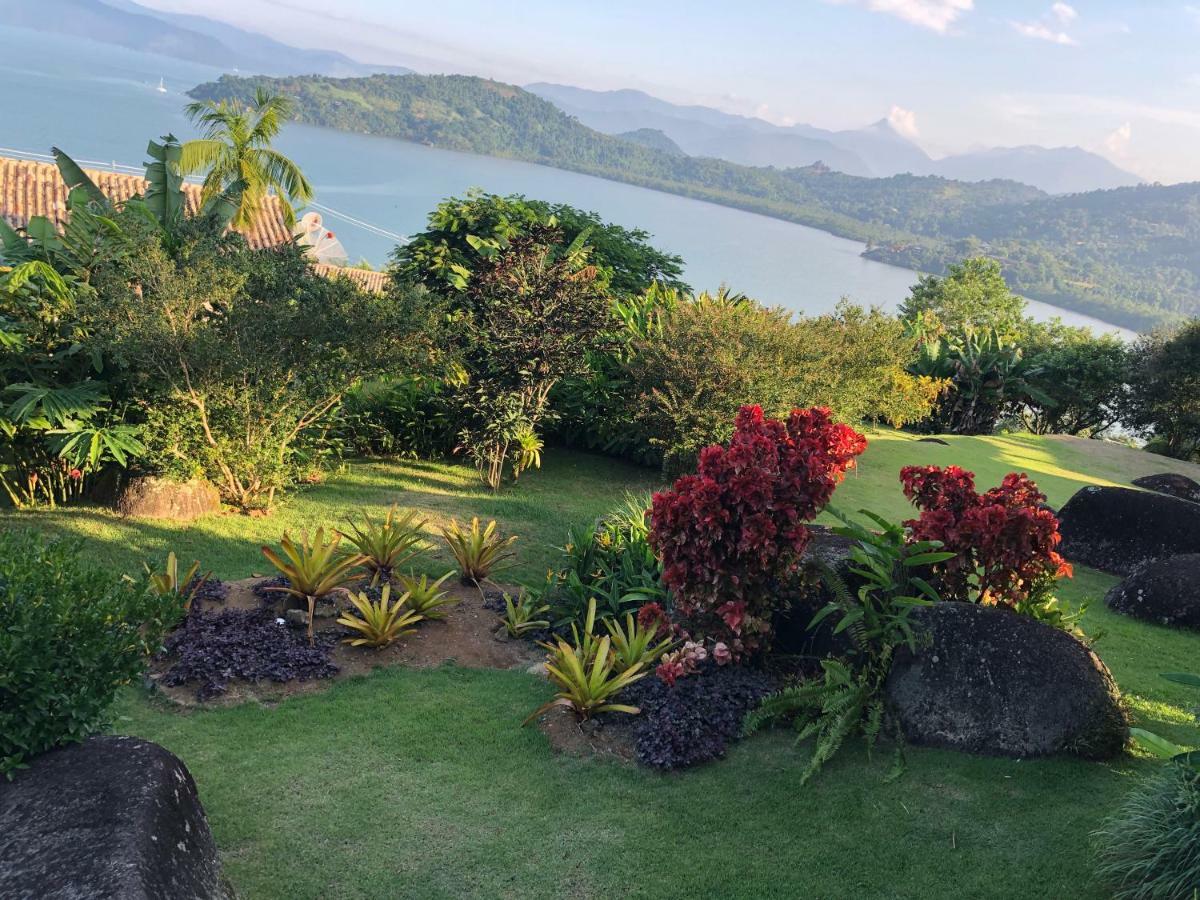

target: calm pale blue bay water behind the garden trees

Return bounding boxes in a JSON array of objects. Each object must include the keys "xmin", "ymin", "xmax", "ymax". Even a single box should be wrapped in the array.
[{"xmin": 0, "ymin": 26, "xmax": 1130, "ymax": 335}]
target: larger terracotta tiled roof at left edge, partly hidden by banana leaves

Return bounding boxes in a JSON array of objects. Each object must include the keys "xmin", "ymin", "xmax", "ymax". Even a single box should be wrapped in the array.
[{"xmin": 0, "ymin": 156, "xmax": 292, "ymax": 250}]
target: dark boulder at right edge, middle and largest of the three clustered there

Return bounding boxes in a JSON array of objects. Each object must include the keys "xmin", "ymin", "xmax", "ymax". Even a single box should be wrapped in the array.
[{"xmin": 1058, "ymin": 486, "xmax": 1200, "ymax": 575}]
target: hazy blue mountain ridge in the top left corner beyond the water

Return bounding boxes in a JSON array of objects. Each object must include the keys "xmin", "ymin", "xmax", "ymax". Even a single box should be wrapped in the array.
[{"xmin": 0, "ymin": 0, "xmax": 412, "ymax": 76}]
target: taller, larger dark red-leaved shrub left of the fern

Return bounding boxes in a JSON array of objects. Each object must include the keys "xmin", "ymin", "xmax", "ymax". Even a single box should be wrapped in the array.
[{"xmin": 650, "ymin": 407, "xmax": 866, "ymax": 656}]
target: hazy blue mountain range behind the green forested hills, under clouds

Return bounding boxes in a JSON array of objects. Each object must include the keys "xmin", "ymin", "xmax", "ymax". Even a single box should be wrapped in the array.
[{"xmin": 526, "ymin": 83, "xmax": 1141, "ymax": 193}]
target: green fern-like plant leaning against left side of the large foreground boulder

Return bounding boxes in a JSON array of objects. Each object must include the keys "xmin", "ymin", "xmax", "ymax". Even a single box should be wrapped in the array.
[{"xmin": 744, "ymin": 510, "xmax": 954, "ymax": 784}]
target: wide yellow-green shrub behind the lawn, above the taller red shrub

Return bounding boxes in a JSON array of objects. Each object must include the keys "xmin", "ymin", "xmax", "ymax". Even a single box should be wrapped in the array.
[{"xmin": 624, "ymin": 296, "xmax": 941, "ymax": 476}]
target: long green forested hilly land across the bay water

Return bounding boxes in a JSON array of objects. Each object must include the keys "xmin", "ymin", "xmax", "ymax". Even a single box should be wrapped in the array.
[{"xmin": 190, "ymin": 74, "xmax": 1200, "ymax": 330}]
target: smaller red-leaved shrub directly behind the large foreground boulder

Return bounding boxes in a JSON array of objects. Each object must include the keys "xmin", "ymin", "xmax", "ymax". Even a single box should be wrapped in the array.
[{"xmin": 900, "ymin": 466, "xmax": 1070, "ymax": 606}]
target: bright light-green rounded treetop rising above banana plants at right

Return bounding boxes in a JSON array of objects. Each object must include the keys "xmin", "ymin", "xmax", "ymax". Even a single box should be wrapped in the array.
[{"xmin": 900, "ymin": 257, "xmax": 1025, "ymax": 338}]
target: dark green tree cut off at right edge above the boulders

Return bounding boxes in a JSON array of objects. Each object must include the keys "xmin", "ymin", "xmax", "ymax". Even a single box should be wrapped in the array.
[{"xmin": 1122, "ymin": 319, "xmax": 1200, "ymax": 460}]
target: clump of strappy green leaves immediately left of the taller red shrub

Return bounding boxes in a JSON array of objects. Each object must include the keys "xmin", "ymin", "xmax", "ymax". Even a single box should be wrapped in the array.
[{"xmin": 540, "ymin": 494, "xmax": 666, "ymax": 625}]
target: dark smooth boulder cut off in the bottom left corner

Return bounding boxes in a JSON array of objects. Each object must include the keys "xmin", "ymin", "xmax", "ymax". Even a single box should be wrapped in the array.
[{"xmin": 0, "ymin": 737, "xmax": 230, "ymax": 900}]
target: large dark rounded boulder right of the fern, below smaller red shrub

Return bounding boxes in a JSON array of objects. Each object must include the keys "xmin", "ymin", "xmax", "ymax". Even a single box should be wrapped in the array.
[{"xmin": 887, "ymin": 602, "xmax": 1129, "ymax": 760}]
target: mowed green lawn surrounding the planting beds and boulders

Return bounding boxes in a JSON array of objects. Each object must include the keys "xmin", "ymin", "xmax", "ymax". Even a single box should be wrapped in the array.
[{"xmin": 7, "ymin": 432, "xmax": 1200, "ymax": 900}]
